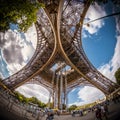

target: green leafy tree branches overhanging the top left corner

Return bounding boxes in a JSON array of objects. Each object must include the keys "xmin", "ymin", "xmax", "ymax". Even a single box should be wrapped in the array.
[{"xmin": 0, "ymin": 0, "xmax": 44, "ymax": 32}]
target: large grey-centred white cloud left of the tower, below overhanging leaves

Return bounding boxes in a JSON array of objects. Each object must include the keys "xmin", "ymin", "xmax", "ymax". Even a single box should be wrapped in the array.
[{"xmin": 0, "ymin": 24, "xmax": 37, "ymax": 75}]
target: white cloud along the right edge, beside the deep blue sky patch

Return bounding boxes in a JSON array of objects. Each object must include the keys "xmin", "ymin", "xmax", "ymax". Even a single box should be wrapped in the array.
[{"xmin": 98, "ymin": 18, "xmax": 120, "ymax": 81}]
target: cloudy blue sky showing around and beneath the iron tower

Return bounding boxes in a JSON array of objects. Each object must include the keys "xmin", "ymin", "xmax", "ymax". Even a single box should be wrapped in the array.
[{"xmin": 0, "ymin": 0, "xmax": 120, "ymax": 105}]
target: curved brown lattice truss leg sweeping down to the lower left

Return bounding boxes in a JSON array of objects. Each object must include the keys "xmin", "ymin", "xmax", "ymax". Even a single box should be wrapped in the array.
[{"xmin": 2, "ymin": 9, "xmax": 54, "ymax": 89}]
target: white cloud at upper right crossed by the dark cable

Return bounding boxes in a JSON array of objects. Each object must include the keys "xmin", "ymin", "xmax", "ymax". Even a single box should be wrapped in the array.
[{"xmin": 83, "ymin": 3, "xmax": 106, "ymax": 37}]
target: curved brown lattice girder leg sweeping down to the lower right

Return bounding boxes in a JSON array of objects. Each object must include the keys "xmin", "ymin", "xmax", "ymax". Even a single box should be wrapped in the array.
[{"xmin": 60, "ymin": 2, "xmax": 118, "ymax": 94}]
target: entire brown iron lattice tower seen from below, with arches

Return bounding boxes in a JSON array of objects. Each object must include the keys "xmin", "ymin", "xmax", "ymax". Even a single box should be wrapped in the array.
[{"xmin": 2, "ymin": 0, "xmax": 119, "ymax": 108}]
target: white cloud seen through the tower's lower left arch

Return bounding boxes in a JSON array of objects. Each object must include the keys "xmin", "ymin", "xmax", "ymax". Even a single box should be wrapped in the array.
[{"xmin": 16, "ymin": 84, "xmax": 49, "ymax": 103}]
